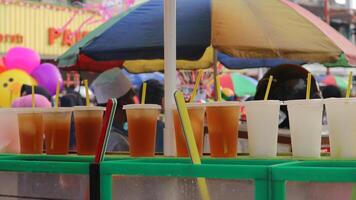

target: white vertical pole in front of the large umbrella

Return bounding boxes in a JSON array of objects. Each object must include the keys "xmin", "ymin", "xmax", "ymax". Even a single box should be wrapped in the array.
[{"xmin": 163, "ymin": 0, "xmax": 177, "ymax": 156}]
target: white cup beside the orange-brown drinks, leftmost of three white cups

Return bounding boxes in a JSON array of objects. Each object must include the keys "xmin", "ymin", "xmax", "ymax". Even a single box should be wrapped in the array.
[{"xmin": 244, "ymin": 100, "xmax": 281, "ymax": 157}]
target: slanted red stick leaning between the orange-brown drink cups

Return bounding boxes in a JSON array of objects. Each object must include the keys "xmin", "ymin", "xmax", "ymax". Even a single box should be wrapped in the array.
[{"xmin": 95, "ymin": 99, "xmax": 113, "ymax": 163}]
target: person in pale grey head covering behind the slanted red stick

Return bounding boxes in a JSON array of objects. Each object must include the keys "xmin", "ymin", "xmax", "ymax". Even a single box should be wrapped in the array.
[{"xmin": 91, "ymin": 68, "xmax": 135, "ymax": 151}]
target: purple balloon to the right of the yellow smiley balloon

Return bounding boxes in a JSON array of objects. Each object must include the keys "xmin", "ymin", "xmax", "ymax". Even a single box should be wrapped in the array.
[{"xmin": 31, "ymin": 63, "xmax": 63, "ymax": 95}]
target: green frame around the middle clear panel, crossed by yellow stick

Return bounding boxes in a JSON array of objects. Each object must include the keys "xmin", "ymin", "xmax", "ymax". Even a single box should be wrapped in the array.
[{"xmin": 100, "ymin": 157, "xmax": 289, "ymax": 200}]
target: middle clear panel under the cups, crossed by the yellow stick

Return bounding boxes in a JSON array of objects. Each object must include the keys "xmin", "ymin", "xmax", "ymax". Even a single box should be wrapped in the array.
[{"xmin": 113, "ymin": 176, "xmax": 254, "ymax": 200}]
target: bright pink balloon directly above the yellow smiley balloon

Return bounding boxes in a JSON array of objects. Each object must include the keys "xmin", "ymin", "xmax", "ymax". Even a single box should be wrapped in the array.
[{"xmin": 4, "ymin": 47, "xmax": 41, "ymax": 73}]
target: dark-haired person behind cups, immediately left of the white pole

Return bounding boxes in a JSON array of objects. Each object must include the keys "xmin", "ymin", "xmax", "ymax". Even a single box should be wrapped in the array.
[{"xmin": 140, "ymin": 79, "xmax": 164, "ymax": 153}]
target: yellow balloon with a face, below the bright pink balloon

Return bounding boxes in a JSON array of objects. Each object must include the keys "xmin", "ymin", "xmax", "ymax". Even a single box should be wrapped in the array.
[{"xmin": 0, "ymin": 69, "xmax": 37, "ymax": 108}]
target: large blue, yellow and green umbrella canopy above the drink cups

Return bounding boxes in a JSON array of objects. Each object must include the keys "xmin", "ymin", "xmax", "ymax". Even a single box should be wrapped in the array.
[{"xmin": 59, "ymin": 0, "xmax": 356, "ymax": 72}]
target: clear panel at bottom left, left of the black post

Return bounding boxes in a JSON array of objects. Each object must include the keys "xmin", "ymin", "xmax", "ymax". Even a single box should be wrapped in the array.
[{"xmin": 0, "ymin": 172, "xmax": 89, "ymax": 200}]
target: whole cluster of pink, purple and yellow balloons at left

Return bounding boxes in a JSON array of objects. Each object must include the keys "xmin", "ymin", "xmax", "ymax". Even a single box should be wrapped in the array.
[{"xmin": 0, "ymin": 47, "xmax": 63, "ymax": 107}]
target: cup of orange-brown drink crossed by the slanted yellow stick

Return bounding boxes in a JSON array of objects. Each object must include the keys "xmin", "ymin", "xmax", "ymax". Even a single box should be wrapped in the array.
[{"xmin": 173, "ymin": 103, "xmax": 205, "ymax": 157}]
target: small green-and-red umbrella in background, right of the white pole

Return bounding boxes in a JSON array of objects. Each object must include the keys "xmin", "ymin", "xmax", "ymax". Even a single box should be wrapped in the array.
[{"xmin": 220, "ymin": 73, "xmax": 258, "ymax": 96}]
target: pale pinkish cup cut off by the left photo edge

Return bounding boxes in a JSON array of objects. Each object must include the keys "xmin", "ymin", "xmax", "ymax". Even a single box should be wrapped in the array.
[{"xmin": 0, "ymin": 108, "xmax": 20, "ymax": 153}]
